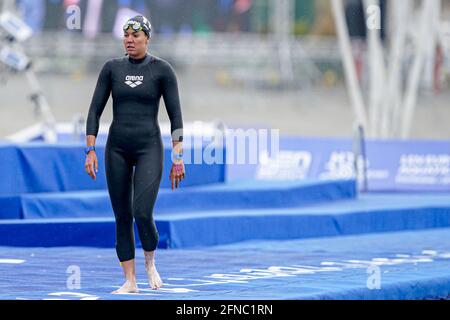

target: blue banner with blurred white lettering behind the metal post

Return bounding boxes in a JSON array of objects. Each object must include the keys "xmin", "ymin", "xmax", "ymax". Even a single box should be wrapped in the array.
[{"xmin": 227, "ymin": 137, "xmax": 450, "ymax": 191}]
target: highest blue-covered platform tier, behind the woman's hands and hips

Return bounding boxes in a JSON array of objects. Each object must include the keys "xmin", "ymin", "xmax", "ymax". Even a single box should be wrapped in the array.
[{"xmin": 0, "ymin": 143, "xmax": 225, "ymax": 197}]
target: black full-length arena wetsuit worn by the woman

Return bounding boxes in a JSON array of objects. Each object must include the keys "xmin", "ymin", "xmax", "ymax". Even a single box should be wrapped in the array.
[{"xmin": 86, "ymin": 55, "xmax": 183, "ymax": 262}]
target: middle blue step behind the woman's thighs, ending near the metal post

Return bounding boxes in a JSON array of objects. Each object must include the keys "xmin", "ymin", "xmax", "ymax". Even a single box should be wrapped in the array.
[{"xmin": 0, "ymin": 180, "xmax": 356, "ymax": 219}]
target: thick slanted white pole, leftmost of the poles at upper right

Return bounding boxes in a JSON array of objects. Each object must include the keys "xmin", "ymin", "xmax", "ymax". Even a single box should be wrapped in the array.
[{"xmin": 331, "ymin": 0, "xmax": 370, "ymax": 129}]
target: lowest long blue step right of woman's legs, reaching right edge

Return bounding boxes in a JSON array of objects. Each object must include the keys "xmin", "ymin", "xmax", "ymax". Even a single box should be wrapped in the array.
[{"xmin": 158, "ymin": 194, "xmax": 450, "ymax": 248}]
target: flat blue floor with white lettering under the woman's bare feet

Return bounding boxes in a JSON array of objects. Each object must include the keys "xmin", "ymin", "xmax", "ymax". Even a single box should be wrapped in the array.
[{"xmin": 0, "ymin": 229, "xmax": 450, "ymax": 300}]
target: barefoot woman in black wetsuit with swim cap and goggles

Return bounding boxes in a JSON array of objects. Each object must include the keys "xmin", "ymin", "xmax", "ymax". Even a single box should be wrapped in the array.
[{"xmin": 85, "ymin": 16, "xmax": 185, "ymax": 294}]
